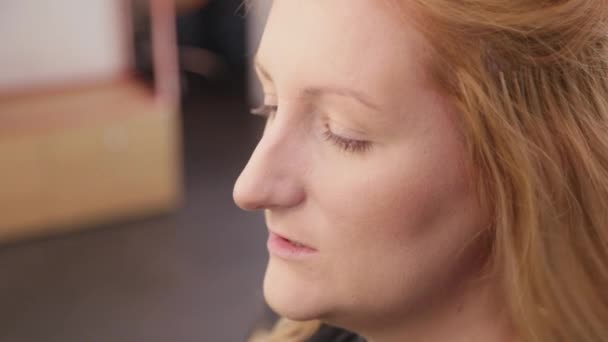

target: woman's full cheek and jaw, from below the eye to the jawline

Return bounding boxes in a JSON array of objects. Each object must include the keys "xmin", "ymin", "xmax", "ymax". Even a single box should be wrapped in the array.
[{"xmin": 306, "ymin": 141, "xmax": 483, "ymax": 313}]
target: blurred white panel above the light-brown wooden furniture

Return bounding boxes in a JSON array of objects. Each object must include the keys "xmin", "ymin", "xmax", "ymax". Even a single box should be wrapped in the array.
[{"xmin": 0, "ymin": 0, "xmax": 130, "ymax": 92}]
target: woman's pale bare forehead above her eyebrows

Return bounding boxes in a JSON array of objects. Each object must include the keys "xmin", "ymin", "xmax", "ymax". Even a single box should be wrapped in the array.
[{"xmin": 258, "ymin": 0, "xmax": 428, "ymax": 100}]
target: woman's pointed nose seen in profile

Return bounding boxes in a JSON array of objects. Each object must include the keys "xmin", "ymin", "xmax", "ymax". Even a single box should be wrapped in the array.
[{"xmin": 233, "ymin": 119, "xmax": 305, "ymax": 211}]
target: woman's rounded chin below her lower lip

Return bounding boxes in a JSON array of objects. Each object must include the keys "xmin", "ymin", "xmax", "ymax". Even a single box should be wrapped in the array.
[{"xmin": 264, "ymin": 258, "xmax": 330, "ymax": 321}]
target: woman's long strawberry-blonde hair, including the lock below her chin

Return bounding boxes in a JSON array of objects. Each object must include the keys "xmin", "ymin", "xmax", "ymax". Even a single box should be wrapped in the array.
[{"xmin": 252, "ymin": 0, "xmax": 608, "ymax": 342}]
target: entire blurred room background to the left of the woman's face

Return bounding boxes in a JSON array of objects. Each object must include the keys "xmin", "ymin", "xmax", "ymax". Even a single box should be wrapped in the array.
[{"xmin": 0, "ymin": 0, "xmax": 270, "ymax": 342}]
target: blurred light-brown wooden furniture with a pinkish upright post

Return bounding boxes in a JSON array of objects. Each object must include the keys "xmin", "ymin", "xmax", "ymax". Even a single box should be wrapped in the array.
[{"xmin": 0, "ymin": 0, "xmax": 181, "ymax": 242}]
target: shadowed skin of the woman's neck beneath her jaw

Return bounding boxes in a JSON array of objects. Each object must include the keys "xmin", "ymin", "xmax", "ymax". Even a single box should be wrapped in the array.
[{"xmin": 354, "ymin": 279, "xmax": 517, "ymax": 342}]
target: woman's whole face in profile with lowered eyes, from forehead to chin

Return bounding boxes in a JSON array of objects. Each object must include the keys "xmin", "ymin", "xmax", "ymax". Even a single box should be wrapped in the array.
[{"xmin": 234, "ymin": 0, "xmax": 487, "ymax": 332}]
